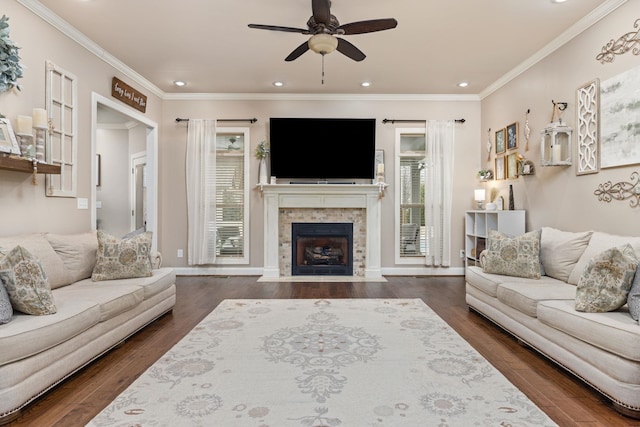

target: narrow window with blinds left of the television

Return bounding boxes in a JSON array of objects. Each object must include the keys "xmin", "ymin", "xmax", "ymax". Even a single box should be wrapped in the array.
[{"xmin": 209, "ymin": 128, "xmax": 249, "ymax": 264}]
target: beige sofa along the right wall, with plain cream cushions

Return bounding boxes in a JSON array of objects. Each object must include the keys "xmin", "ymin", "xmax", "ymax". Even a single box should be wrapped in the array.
[{"xmin": 466, "ymin": 228, "xmax": 640, "ymax": 418}]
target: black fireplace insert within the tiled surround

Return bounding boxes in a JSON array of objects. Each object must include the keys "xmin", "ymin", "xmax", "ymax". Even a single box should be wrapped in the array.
[{"xmin": 291, "ymin": 222, "xmax": 353, "ymax": 276}]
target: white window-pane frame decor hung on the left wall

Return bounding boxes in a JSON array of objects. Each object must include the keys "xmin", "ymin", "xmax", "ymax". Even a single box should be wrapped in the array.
[{"xmin": 45, "ymin": 61, "xmax": 78, "ymax": 197}]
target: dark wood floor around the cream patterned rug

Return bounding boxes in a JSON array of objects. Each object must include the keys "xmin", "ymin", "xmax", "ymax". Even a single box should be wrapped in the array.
[{"xmin": 9, "ymin": 276, "xmax": 640, "ymax": 427}]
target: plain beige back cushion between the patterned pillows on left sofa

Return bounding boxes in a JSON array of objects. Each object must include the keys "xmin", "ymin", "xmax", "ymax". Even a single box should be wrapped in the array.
[{"xmin": 44, "ymin": 231, "xmax": 98, "ymax": 284}]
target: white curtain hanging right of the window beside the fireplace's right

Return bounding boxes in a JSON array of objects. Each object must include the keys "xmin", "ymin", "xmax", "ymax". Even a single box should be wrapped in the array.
[{"xmin": 424, "ymin": 120, "xmax": 455, "ymax": 267}]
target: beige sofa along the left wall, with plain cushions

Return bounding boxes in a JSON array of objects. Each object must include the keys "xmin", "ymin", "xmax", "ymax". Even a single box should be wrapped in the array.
[{"xmin": 0, "ymin": 232, "xmax": 175, "ymax": 424}]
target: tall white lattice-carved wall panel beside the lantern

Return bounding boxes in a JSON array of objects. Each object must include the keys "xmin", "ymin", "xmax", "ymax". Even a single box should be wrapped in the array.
[{"xmin": 576, "ymin": 79, "xmax": 600, "ymax": 175}]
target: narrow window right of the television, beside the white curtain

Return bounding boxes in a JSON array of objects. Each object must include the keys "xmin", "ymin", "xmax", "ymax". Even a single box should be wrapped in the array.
[{"xmin": 395, "ymin": 128, "xmax": 426, "ymax": 263}]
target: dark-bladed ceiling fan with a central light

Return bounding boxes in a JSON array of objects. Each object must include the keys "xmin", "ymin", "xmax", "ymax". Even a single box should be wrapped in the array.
[{"xmin": 249, "ymin": 0, "xmax": 398, "ymax": 61}]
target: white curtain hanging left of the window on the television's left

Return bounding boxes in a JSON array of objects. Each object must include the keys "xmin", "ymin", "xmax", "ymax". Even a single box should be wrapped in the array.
[{"xmin": 186, "ymin": 119, "xmax": 216, "ymax": 265}]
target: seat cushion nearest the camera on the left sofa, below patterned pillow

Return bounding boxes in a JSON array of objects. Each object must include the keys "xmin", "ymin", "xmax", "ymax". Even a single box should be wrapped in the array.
[{"xmin": 0, "ymin": 300, "xmax": 100, "ymax": 366}]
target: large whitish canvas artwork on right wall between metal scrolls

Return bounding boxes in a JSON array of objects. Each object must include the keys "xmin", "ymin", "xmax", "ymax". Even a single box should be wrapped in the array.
[{"xmin": 600, "ymin": 66, "xmax": 640, "ymax": 169}]
